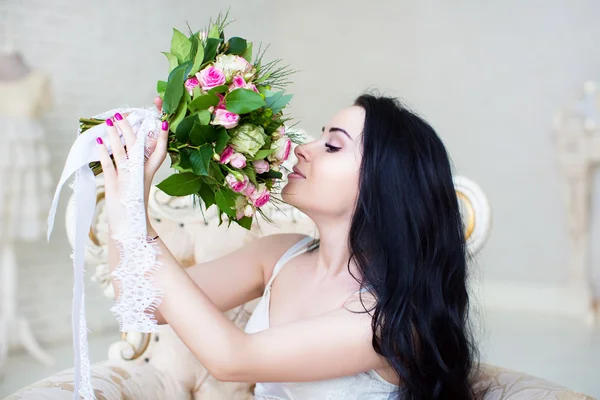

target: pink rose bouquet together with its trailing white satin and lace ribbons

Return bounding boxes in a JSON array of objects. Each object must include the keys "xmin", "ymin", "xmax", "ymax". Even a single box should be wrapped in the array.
[{"xmin": 48, "ymin": 16, "xmax": 301, "ymax": 400}]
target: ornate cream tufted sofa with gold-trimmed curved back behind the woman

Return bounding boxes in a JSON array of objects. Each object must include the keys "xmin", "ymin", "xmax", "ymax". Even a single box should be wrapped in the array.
[{"xmin": 5, "ymin": 177, "xmax": 591, "ymax": 400}]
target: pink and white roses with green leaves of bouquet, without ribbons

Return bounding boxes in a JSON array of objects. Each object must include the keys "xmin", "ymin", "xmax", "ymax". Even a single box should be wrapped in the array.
[{"xmin": 80, "ymin": 13, "xmax": 301, "ymax": 229}]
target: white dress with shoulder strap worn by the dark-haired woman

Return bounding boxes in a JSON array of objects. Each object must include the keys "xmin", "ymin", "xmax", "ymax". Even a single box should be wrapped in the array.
[{"xmin": 245, "ymin": 237, "xmax": 398, "ymax": 400}]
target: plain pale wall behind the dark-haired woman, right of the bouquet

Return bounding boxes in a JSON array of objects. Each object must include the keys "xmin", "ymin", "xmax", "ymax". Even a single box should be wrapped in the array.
[{"xmin": 274, "ymin": 0, "xmax": 600, "ymax": 283}]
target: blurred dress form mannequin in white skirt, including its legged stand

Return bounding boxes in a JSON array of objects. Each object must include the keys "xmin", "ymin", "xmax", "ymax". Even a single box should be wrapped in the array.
[{"xmin": 0, "ymin": 47, "xmax": 53, "ymax": 375}]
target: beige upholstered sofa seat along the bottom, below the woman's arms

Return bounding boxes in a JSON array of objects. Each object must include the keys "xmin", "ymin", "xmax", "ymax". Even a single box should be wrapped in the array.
[{"xmin": 5, "ymin": 301, "xmax": 593, "ymax": 400}]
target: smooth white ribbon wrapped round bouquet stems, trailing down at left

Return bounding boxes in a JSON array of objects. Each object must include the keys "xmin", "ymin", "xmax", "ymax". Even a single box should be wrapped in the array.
[{"xmin": 47, "ymin": 107, "xmax": 160, "ymax": 400}]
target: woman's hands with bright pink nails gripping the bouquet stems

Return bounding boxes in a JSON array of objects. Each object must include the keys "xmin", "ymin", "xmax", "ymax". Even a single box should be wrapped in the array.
[{"xmin": 96, "ymin": 113, "xmax": 169, "ymax": 232}]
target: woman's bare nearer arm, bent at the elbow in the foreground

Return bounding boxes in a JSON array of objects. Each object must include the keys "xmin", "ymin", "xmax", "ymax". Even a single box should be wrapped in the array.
[{"xmin": 148, "ymin": 235, "xmax": 385, "ymax": 382}]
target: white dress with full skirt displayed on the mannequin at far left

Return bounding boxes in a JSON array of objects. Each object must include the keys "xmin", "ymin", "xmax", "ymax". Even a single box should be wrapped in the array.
[{"xmin": 0, "ymin": 71, "xmax": 53, "ymax": 242}]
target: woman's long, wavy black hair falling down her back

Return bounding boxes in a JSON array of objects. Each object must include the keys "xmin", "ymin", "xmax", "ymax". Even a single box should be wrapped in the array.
[{"xmin": 316, "ymin": 94, "xmax": 477, "ymax": 400}]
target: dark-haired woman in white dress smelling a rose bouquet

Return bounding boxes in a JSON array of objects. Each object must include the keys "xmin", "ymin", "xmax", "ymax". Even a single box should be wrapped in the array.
[{"xmin": 99, "ymin": 95, "xmax": 482, "ymax": 400}]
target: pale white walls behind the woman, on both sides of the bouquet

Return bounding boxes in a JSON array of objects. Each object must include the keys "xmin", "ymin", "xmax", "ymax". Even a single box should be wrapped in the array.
[{"xmin": 11, "ymin": 0, "xmax": 600, "ymax": 341}]
